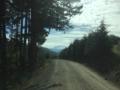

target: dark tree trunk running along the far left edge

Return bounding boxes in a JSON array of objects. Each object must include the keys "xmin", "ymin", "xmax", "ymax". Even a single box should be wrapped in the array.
[{"xmin": 0, "ymin": 0, "xmax": 8, "ymax": 90}]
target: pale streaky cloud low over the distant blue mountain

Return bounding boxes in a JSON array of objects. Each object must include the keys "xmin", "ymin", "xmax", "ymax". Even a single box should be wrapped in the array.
[{"xmin": 43, "ymin": 27, "xmax": 91, "ymax": 48}]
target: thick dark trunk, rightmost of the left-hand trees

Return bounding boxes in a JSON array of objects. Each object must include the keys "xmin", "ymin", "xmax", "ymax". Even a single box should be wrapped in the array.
[{"xmin": 29, "ymin": 1, "xmax": 37, "ymax": 67}]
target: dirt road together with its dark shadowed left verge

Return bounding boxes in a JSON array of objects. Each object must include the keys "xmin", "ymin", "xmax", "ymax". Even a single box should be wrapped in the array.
[{"xmin": 22, "ymin": 60, "xmax": 120, "ymax": 90}]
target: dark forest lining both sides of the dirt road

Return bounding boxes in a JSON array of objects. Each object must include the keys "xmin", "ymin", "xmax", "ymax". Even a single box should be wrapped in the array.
[{"xmin": 0, "ymin": 0, "xmax": 120, "ymax": 90}]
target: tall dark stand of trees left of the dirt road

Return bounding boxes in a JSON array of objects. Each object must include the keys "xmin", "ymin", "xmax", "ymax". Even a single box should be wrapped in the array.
[{"xmin": 0, "ymin": 0, "xmax": 82, "ymax": 90}]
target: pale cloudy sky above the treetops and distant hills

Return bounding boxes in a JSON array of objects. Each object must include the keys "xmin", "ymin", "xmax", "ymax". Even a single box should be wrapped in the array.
[{"xmin": 42, "ymin": 0, "xmax": 120, "ymax": 50}]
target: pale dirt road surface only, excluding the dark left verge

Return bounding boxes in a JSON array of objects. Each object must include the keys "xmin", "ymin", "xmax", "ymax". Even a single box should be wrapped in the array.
[{"xmin": 47, "ymin": 60, "xmax": 120, "ymax": 90}]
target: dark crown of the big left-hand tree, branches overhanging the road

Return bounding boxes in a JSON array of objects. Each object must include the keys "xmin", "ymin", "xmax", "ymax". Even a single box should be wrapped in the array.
[{"xmin": 30, "ymin": 0, "xmax": 82, "ymax": 42}]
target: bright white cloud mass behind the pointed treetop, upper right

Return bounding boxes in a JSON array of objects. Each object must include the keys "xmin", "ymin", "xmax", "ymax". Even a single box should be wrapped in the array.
[{"xmin": 71, "ymin": 0, "xmax": 120, "ymax": 32}]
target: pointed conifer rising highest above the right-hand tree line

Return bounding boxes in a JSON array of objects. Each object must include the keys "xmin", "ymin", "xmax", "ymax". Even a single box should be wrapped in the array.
[{"xmin": 85, "ymin": 22, "xmax": 111, "ymax": 58}]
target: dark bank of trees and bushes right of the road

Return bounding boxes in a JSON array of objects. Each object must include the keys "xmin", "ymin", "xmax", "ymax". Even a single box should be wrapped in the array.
[{"xmin": 60, "ymin": 21, "xmax": 120, "ymax": 86}]
